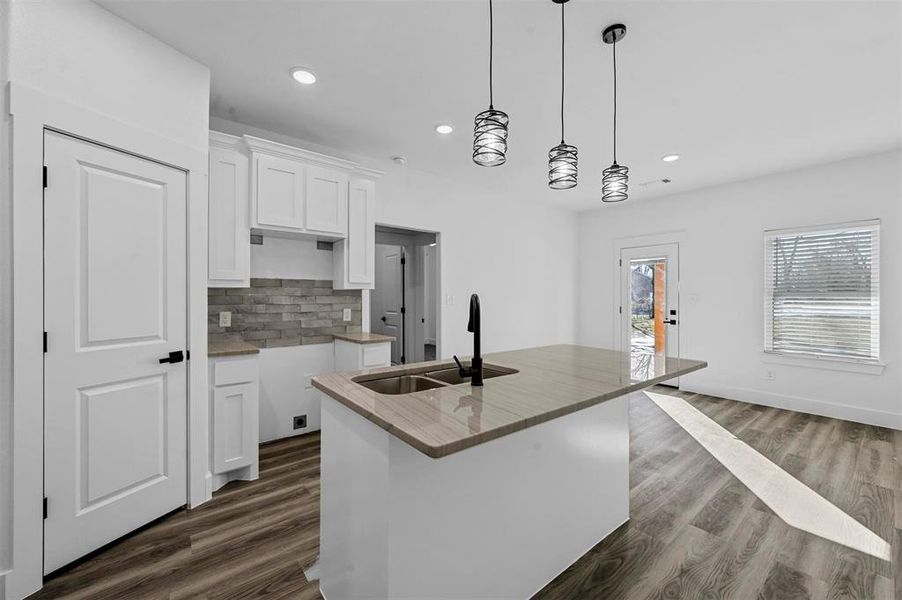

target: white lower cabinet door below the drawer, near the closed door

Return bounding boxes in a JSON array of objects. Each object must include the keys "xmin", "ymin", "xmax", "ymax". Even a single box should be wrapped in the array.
[{"xmin": 213, "ymin": 383, "xmax": 258, "ymax": 473}]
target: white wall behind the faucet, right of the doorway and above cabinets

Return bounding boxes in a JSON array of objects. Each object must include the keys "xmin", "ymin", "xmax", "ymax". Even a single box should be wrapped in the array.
[{"xmin": 211, "ymin": 118, "xmax": 577, "ymax": 358}]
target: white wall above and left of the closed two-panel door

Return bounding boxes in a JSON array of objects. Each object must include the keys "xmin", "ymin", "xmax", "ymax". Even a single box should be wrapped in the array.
[{"xmin": 0, "ymin": 0, "xmax": 210, "ymax": 598}]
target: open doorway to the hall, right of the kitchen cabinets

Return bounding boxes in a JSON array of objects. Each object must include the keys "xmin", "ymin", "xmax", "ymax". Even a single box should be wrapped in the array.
[{"xmin": 370, "ymin": 225, "xmax": 440, "ymax": 365}]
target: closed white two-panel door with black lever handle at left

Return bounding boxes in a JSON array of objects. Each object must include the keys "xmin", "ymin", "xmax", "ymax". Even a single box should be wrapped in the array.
[{"xmin": 44, "ymin": 131, "xmax": 187, "ymax": 573}]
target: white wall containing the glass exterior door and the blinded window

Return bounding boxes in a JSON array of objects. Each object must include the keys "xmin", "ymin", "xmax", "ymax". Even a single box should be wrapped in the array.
[{"xmin": 579, "ymin": 152, "xmax": 902, "ymax": 428}]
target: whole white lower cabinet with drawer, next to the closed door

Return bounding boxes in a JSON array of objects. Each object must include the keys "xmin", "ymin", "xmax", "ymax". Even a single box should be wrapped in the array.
[{"xmin": 210, "ymin": 355, "xmax": 260, "ymax": 490}]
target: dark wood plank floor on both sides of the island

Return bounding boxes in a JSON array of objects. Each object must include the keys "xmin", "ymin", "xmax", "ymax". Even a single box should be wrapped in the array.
[{"xmin": 31, "ymin": 388, "xmax": 902, "ymax": 600}]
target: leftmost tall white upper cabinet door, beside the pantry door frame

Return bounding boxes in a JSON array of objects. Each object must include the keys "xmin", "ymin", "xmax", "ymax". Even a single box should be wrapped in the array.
[{"xmin": 208, "ymin": 146, "xmax": 251, "ymax": 287}]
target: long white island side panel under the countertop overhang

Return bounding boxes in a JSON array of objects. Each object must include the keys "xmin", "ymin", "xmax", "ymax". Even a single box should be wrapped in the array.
[{"xmin": 386, "ymin": 396, "xmax": 629, "ymax": 598}]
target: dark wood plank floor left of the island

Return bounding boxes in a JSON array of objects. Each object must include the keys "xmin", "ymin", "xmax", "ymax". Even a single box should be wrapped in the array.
[{"xmin": 29, "ymin": 433, "xmax": 321, "ymax": 600}]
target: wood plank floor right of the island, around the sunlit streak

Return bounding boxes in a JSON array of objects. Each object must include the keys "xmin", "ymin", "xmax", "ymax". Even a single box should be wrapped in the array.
[{"xmin": 536, "ymin": 387, "xmax": 902, "ymax": 600}]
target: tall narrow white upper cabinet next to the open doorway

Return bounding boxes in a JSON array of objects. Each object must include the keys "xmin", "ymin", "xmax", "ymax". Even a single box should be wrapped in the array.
[{"xmin": 332, "ymin": 179, "xmax": 376, "ymax": 290}]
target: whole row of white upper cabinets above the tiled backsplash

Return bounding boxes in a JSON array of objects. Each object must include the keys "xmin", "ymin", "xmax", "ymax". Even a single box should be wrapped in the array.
[{"xmin": 209, "ymin": 132, "xmax": 382, "ymax": 289}]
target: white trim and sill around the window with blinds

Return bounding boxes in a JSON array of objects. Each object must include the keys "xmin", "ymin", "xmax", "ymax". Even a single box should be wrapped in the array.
[{"xmin": 760, "ymin": 219, "xmax": 886, "ymax": 375}]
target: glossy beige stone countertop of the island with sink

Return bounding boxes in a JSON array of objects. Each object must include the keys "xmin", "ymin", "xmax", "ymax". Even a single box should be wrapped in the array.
[{"xmin": 313, "ymin": 345, "xmax": 707, "ymax": 458}]
